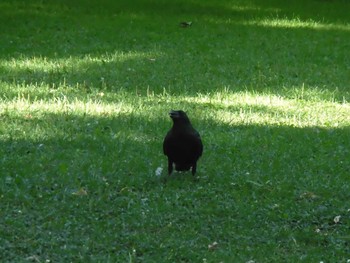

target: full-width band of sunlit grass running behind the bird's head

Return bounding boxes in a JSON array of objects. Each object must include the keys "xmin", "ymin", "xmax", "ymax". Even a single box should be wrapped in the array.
[{"xmin": 0, "ymin": 89, "xmax": 350, "ymax": 134}]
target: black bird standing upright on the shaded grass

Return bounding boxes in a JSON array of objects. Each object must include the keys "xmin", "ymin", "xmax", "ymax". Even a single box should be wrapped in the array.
[{"xmin": 163, "ymin": 110, "xmax": 203, "ymax": 175}]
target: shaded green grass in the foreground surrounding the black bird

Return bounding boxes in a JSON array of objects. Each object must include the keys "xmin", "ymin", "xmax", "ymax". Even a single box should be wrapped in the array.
[{"xmin": 0, "ymin": 108, "xmax": 350, "ymax": 261}]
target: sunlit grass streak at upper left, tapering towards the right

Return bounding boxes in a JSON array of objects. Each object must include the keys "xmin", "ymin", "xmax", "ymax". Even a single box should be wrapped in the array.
[{"xmin": 0, "ymin": 51, "xmax": 161, "ymax": 88}]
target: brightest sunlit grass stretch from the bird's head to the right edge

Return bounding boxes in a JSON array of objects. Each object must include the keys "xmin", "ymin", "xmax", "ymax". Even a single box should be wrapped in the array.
[{"xmin": 184, "ymin": 92, "xmax": 350, "ymax": 128}]
